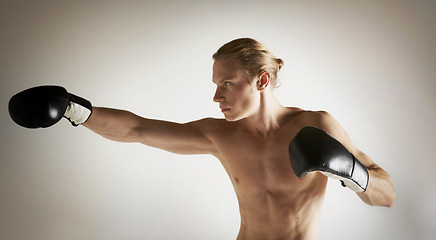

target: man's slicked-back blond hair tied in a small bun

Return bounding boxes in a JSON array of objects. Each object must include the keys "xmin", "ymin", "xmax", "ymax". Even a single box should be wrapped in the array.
[{"xmin": 212, "ymin": 38, "xmax": 284, "ymax": 88}]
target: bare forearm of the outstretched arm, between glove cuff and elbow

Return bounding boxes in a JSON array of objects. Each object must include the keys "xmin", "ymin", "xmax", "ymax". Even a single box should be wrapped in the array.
[{"xmin": 82, "ymin": 107, "xmax": 141, "ymax": 142}]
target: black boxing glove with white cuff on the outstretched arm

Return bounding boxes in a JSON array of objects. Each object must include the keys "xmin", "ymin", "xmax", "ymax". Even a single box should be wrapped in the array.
[{"xmin": 9, "ymin": 86, "xmax": 92, "ymax": 128}]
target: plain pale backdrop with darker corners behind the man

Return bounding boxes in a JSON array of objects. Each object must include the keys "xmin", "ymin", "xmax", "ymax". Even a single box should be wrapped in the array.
[{"xmin": 0, "ymin": 0, "xmax": 436, "ymax": 240}]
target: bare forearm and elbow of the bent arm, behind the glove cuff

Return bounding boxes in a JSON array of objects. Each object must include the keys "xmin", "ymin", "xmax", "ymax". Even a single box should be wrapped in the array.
[{"xmin": 357, "ymin": 166, "xmax": 396, "ymax": 207}]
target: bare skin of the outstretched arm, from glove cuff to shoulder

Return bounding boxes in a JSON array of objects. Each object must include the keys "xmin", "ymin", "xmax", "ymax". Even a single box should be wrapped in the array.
[{"xmin": 82, "ymin": 107, "xmax": 215, "ymax": 154}]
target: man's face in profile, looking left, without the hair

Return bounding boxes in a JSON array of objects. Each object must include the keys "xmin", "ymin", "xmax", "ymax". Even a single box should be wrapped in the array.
[{"xmin": 212, "ymin": 58, "xmax": 260, "ymax": 121}]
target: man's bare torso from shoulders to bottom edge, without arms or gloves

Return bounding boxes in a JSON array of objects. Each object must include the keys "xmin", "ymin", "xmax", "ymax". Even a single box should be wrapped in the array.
[{"xmin": 204, "ymin": 109, "xmax": 327, "ymax": 240}]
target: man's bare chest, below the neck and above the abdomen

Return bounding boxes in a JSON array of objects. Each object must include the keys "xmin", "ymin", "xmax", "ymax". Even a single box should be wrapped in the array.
[{"xmin": 217, "ymin": 129, "xmax": 297, "ymax": 192}]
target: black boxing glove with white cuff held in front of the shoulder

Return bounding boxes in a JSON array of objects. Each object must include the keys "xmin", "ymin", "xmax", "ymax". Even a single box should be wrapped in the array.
[{"xmin": 289, "ymin": 126, "xmax": 369, "ymax": 192}]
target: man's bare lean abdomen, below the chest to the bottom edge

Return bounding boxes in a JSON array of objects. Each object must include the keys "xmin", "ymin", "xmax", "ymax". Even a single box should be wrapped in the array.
[{"xmin": 235, "ymin": 173, "xmax": 327, "ymax": 240}]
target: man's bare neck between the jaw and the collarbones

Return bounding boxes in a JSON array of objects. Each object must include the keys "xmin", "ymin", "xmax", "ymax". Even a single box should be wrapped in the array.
[{"xmin": 241, "ymin": 90, "xmax": 286, "ymax": 136}]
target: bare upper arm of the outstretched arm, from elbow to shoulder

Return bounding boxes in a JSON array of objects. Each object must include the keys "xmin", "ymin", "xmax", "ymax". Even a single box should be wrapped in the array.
[{"xmin": 135, "ymin": 119, "xmax": 214, "ymax": 154}]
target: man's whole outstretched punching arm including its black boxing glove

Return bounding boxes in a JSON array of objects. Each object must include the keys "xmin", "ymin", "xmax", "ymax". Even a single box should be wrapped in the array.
[{"xmin": 9, "ymin": 86, "xmax": 214, "ymax": 154}]
